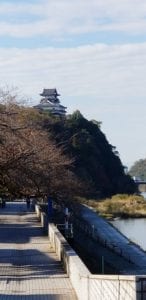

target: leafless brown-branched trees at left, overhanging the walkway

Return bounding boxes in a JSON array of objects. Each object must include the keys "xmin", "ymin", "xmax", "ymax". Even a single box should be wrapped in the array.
[{"xmin": 0, "ymin": 92, "xmax": 80, "ymax": 198}]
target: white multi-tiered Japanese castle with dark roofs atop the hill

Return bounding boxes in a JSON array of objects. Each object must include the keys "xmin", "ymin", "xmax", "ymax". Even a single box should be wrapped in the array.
[{"xmin": 34, "ymin": 89, "xmax": 66, "ymax": 116}]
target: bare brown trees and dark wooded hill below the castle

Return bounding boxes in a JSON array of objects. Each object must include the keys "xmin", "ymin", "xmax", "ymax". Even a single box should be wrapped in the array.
[{"xmin": 0, "ymin": 90, "xmax": 136, "ymax": 199}]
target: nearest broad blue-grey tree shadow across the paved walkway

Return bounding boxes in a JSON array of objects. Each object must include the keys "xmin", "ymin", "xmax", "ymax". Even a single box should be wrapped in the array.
[{"xmin": 0, "ymin": 249, "xmax": 64, "ymax": 278}]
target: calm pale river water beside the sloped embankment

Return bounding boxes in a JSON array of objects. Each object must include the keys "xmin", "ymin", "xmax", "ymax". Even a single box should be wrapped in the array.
[{"xmin": 111, "ymin": 193, "xmax": 146, "ymax": 250}]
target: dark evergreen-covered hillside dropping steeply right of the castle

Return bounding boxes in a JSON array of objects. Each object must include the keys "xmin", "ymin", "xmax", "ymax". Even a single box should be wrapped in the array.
[{"xmin": 44, "ymin": 111, "xmax": 136, "ymax": 197}]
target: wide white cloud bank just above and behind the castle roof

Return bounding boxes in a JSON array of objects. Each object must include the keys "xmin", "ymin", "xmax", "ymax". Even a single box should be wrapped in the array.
[{"xmin": 0, "ymin": 43, "xmax": 146, "ymax": 99}]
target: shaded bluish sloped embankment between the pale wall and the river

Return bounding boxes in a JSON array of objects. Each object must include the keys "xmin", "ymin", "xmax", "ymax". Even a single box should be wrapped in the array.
[{"xmin": 75, "ymin": 206, "xmax": 146, "ymax": 274}]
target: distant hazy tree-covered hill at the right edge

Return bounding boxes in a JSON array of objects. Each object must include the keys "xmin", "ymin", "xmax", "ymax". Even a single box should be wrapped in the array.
[{"xmin": 129, "ymin": 159, "xmax": 146, "ymax": 180}]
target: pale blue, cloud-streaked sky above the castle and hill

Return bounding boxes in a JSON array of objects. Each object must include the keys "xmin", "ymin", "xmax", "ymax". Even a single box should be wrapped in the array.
[{"xmin": 0, "ymin": 0, "xmax": 146, "ymax": 166}]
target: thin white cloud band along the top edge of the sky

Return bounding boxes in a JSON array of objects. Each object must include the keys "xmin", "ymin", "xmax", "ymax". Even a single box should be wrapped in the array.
[{"xmin": 0, "ymin": 0, "xmax": 146, "ymax": 38}]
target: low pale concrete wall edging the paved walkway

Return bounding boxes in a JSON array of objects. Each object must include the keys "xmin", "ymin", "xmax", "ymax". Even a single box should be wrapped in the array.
[{"xmin": 48, "ymin": 220, "xmax": 146, "ymax": 300}]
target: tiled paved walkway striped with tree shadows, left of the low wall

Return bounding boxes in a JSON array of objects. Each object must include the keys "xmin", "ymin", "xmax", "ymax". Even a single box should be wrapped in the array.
[{"xmin": 0, "ymin": 202, "xmax": 77, "ymax": 300}]
